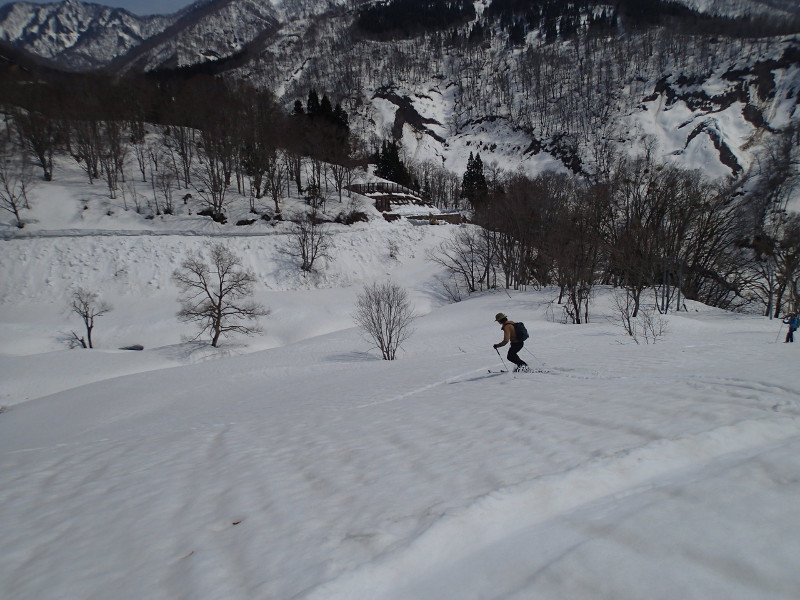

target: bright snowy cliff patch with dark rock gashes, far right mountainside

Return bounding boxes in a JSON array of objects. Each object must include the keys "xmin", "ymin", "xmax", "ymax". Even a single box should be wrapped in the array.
[{"xmin": 628, "ymin": 38, "xmax": 800, "ymax": 178}]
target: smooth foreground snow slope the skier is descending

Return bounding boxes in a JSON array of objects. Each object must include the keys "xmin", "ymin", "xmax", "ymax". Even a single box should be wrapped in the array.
[{"xmin": 0, "ymin": 284, "xmax": 800, "ymax": 600}]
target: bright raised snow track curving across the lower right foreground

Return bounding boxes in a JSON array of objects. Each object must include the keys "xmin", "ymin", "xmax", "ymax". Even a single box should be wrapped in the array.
[{"xmin": 304, "ymin": 417, "xmax": 800, "ymax": 600}]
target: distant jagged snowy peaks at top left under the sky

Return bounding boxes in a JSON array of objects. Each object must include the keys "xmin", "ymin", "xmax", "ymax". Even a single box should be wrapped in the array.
[{"xmin": 0, "ymin": 0, "xmax": 344, "ymax": 71}]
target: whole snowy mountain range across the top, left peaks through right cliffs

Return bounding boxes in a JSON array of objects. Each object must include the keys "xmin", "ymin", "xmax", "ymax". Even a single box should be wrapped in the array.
[{"xmin": 0, "ymin": 0, "xmax": 800, "ymax": 177}]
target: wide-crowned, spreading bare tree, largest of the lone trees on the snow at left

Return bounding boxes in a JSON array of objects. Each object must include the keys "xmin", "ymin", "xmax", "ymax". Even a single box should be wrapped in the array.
[{"xmin": 172, "ymin": 244, "xmax": 269, "ymax": 348}]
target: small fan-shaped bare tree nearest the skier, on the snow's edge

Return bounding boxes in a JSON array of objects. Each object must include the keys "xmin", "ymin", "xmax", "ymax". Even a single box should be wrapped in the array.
[{"xmin": 353, "ymin": 281, "xmax": 414, "ymax": 360}]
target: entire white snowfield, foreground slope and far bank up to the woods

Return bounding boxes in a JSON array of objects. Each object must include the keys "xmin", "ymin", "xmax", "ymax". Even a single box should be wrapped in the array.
[{"xmin": 0, "ymin": 163, "xmax": 800, "ymax": 600}]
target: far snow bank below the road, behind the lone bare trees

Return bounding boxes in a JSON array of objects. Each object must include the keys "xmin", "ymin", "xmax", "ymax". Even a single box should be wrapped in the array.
[{"xmin": 0, "ymin": 223, "xmax": 452, "ymax": 354}]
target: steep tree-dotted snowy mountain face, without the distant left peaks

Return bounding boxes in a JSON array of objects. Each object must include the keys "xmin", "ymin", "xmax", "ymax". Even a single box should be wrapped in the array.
[{"xmin": 223, "ymin": 3, "xmax": 800, "ymax": 177}]
